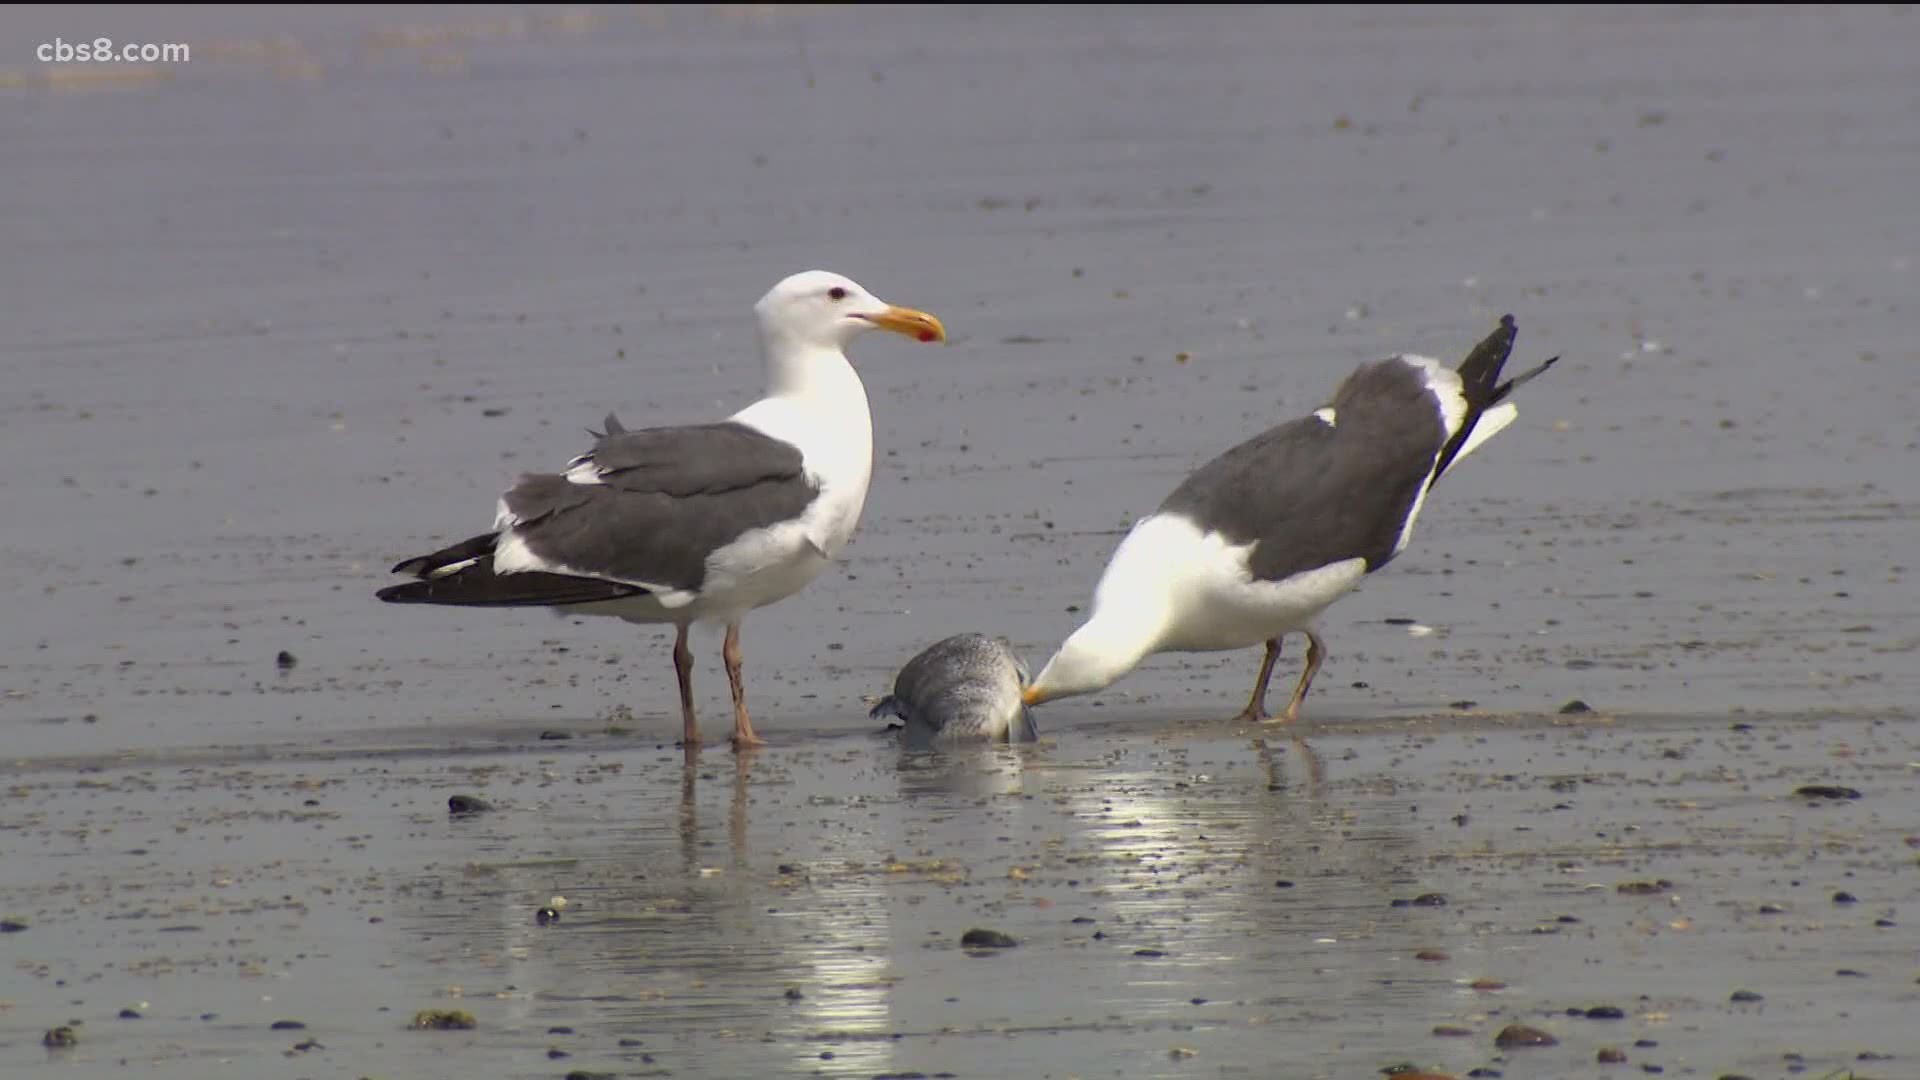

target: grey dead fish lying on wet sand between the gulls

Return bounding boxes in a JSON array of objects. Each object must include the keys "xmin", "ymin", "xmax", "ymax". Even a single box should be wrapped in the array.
[{"xmin": 870, "ymin": 634, "xmax": 1039, "ymax": 746}]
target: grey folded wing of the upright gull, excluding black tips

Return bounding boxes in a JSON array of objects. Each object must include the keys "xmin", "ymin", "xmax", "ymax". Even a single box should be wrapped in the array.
[{"xmin": 501, "ymin": 417, "xmax": 820, "ymax": 590}]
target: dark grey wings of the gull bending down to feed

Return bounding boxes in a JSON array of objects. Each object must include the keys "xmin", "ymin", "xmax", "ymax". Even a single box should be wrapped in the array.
[{"xmin": 1160, "ymin": 359, "xmax": 1446, "ymax": 580}]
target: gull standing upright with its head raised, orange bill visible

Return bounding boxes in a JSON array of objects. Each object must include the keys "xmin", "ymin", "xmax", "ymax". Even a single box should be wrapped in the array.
[{"xmin": 378, "ymin": 271, "xmax": 947, "ymax": 753}]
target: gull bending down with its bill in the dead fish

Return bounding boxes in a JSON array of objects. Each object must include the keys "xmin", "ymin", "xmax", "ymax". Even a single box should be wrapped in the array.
[{"xmin": 1021, "ymin": 315, "xmax": 1559, "ymax": 723}]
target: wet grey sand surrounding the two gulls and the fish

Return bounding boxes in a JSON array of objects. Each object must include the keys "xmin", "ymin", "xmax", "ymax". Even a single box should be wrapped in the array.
[{"xmin": 0, "ymin": 8, "xmax": 1920, "ymax": 1078}]
